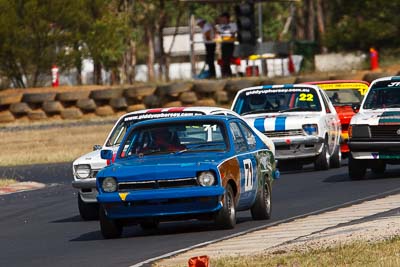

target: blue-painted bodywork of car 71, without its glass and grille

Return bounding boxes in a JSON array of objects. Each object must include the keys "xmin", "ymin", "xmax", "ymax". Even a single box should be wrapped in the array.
[{"xmin": 96, "ymin": 115, "xmax": 274, "ymax": 222}]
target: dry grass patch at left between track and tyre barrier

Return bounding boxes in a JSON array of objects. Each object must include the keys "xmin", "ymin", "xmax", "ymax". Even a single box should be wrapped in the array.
[{"xmin": 0, "ymin": 125, "xmax": 112, "ymax": 166}]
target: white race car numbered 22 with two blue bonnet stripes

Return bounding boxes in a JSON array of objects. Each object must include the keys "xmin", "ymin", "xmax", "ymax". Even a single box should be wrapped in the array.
[{"xmin": 231, "ymin": 84, "xmax": 341, "ymax": 170}]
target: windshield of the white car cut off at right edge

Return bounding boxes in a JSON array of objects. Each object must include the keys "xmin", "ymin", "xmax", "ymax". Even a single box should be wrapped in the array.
[{"xmin": 363, "ymin": 86, "xmax": 400, "ymax": 109}]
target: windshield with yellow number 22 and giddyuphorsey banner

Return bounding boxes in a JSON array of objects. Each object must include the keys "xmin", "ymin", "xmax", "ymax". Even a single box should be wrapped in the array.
[{"xmin": 233, "ymin": 87, "xmax": 321, "ymax": 115}]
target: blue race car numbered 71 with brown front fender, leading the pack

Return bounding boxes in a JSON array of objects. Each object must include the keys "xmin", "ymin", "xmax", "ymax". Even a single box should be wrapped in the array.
[{"xmin": 96, "ymin": 115, "xmax": 279, "ymax": 238}]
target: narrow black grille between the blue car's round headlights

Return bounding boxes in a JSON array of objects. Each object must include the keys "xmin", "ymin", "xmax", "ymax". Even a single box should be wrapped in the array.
[{"xmin": 118, "ymin": 177, "xmax": 199, "ymax": 191}]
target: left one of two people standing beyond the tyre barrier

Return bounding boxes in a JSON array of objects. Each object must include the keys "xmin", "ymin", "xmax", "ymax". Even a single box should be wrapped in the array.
[{"xmin": 196, "ymin": 18, "xmax": 216, "ymax": 78}]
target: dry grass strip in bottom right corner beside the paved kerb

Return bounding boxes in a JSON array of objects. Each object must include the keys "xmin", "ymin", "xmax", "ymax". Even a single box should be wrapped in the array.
[{"xmin": 211, "ymin": 237, "xmax": 400, "ymax": 267}]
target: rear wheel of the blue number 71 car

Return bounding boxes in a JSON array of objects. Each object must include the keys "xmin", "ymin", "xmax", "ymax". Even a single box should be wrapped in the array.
[{"xmin": 250, "ymin": 182, "xmax": 272, "ymax": 220}]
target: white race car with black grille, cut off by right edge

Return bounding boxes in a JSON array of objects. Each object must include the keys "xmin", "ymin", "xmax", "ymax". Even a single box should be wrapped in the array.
[{"xmin": 348, "ymin": 76, "xmax": 400, "ymax": 179}]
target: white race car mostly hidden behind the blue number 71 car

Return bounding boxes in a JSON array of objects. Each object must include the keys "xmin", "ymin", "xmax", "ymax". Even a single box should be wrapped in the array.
[{"xmin": 72, "ymin": 107, "xmax": 275, "ymax": 220}]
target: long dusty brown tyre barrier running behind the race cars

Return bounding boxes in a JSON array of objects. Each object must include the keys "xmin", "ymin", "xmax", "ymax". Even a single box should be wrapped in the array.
[{"xmin": 0, "ymin": 71, "xmax": 394, "ymax": 124}]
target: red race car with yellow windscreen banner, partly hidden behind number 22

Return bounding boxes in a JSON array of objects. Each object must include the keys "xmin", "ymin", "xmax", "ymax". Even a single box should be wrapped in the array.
[{"xmin": 307, "ymin": 80, "xmax": 369, "ymax": 157}]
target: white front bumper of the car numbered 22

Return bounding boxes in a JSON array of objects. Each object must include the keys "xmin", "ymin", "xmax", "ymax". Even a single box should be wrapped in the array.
[{"xmin": 272, "ymin": 136, "xmax": 325, "ymax": 160}]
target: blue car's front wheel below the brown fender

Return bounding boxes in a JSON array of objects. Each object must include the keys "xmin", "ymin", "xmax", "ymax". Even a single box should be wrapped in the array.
[{"xmin": 215, "ymin": 184, "xmax": 236, "ymax": 229}]
